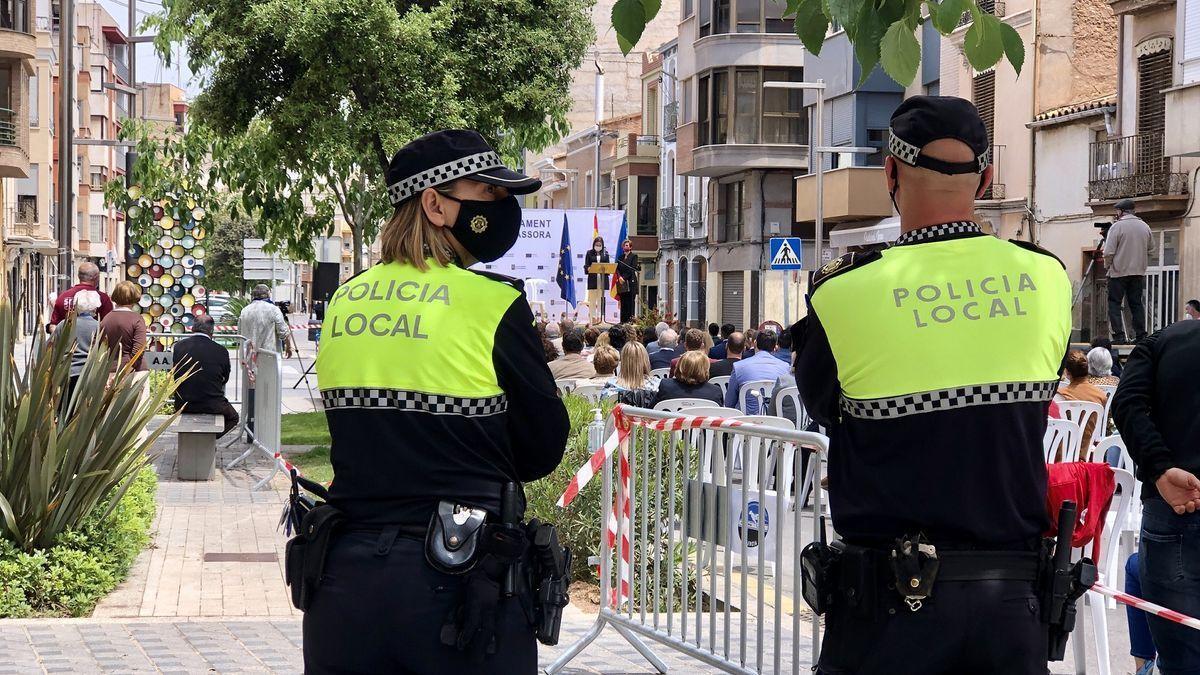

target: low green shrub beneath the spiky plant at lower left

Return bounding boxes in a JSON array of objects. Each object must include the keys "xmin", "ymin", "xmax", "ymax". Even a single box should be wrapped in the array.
[{"xmin": 0, "ymin": 466, "xmax": 158, "ymax": 619}]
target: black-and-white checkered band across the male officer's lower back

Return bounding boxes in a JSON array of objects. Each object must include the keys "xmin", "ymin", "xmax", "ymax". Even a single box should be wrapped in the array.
[{"xmin": 841, "ymin": 380, "xmax": 1058, "ymax": 419}]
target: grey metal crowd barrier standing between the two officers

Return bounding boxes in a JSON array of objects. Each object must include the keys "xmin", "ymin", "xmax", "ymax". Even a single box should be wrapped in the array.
[{"xmin": 546, "ymin": 407, "xmax": 828, "ymax": 674}]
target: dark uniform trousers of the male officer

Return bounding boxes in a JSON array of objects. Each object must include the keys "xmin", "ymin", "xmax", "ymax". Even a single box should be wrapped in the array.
[{"xmin": 818, "ymin": 580, "xmax": 1048, "ymax": 675}]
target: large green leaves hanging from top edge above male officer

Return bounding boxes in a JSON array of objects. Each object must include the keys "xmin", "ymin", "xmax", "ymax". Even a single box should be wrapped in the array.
[{"xmin": 612, "ymin": 0, "xmax": 1025, "ymax": 86}]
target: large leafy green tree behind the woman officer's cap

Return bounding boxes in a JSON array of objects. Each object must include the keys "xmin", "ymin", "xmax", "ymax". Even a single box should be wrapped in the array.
[{"xmin": 148, "ymin": 0, "xmax": 594, "ymax": 273}]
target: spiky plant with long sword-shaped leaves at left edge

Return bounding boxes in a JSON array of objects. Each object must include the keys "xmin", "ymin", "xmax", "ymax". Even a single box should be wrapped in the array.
[{"xmin": 0, "ymin": 303, "xmax": 175, "ymax": 550}]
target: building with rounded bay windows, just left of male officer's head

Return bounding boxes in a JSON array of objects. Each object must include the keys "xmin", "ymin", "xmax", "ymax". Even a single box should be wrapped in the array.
[{"xmin": 664, "ymin": 0, "xmax": 809, "ymax": 327}]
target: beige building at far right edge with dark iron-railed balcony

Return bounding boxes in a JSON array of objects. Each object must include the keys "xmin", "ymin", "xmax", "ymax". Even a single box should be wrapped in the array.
[{"xmin": 1087, "ymin": 0, "xmax": 1200, "ymax": 330}]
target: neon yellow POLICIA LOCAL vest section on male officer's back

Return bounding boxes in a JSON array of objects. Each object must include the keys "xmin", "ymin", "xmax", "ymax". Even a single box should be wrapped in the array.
[{"xmin": 811, "ymin": 237, "xmax": 1070, "ymax": 418}]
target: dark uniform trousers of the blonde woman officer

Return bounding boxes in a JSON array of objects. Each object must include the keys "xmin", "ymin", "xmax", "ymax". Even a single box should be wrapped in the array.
[{"xmin": 304, "ymin": 532, "xmax": 538, "ymax": 675}]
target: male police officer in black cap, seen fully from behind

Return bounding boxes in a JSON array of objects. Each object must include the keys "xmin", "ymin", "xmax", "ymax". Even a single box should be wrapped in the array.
[{"xmin": 792, "ymin": 96, "xmax": 1070, "ymax": 674}]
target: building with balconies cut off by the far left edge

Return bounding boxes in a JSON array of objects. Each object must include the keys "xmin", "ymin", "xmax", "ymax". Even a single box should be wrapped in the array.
[{"xmin": 0, "ymin": 0, "xmax": 47, "ymax": 324}]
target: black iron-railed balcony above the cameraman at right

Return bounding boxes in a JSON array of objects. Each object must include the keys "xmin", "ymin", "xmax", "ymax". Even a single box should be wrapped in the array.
[{"xmin": 1087, "ymin": 131, "xmax": 1188, "ymax": 205}]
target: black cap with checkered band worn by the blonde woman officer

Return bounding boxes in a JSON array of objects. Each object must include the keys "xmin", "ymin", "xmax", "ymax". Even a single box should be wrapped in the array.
[{"xmin": 386, "ymin": 129, "xmax": 541, "ymax": 207}]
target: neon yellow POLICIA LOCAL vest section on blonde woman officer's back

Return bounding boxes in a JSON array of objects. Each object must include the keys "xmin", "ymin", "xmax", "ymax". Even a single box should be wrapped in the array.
[{"xmin": 317, "ymin": 263, "xmax": 520, "ymax": 398}]
